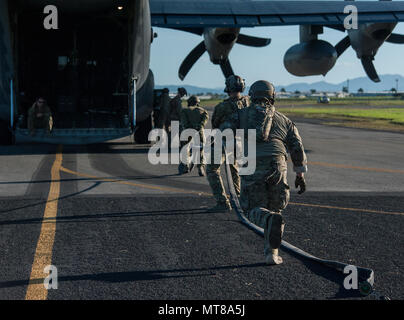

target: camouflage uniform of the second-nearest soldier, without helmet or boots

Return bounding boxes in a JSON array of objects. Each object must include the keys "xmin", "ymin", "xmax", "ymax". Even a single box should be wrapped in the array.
[{"xmin": 206, "ymin": 97, "xmax": 250, "ymax": 204}]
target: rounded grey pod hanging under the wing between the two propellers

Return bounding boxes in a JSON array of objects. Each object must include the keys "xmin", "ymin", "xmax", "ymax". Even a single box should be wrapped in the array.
[{"xmin": 283, "ymin": 40, "xmax": 338, "ymax": 77}]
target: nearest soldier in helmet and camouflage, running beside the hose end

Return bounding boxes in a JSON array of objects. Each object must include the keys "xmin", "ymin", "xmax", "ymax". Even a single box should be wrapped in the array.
[{"xmin": 240, "ymin": 81, "xmax": 307, "ymax": 264}]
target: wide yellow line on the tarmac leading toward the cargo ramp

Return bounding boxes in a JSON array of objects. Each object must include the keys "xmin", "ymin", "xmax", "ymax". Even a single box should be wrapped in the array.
[{"xmin": 25, "ymin": 145, "xmax": 63, "ymax": 300}]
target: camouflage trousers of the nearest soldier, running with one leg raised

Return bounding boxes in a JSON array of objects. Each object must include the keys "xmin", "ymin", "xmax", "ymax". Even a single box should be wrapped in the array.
[{"xmin": 240, "ymin": 156, "xmax": 290, "ymax": 213}]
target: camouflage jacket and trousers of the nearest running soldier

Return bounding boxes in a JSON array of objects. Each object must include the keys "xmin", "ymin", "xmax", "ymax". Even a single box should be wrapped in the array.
[{"xmin": 241, "ymin": 104, "xmax": 307, "ymax": 213}]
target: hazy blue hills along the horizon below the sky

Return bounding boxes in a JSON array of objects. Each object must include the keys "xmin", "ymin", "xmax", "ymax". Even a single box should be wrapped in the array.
[{"xmin": 156, "ymin": 74, "xmax": 404, "ymax": 94}]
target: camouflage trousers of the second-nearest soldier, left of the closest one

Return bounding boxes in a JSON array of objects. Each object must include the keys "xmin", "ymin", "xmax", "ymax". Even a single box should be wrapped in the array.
[{"xmin": 206, "ymin": 150, "xmax": 240, "ymax": 203}]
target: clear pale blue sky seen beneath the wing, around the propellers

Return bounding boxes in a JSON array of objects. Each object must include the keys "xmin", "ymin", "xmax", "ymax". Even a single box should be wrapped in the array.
[{"xmin": 151, "ymin": 0, "xmax": 404, "ymax": 88}]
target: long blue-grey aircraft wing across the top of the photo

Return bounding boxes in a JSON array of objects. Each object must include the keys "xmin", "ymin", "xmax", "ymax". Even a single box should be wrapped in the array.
[{"xmin": 150, "ymin": 0, "xmax": 404, "ymax": 28}]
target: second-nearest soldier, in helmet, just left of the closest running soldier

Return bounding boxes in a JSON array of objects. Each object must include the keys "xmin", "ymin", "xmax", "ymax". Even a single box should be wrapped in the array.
[{"xmin": 206, "ymin": 75, "xmax": 250, "ymax": 212}]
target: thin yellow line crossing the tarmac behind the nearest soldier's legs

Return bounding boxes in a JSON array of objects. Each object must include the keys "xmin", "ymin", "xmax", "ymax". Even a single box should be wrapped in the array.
[{"xmin": 60, "ymin": 167, "xmax": 404, "ymax": 216}]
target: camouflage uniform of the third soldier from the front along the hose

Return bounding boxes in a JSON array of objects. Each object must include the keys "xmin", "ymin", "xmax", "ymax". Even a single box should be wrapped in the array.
[{"xmin": 180, "ymin": 105, "xmax": 209, "ymax": 175}]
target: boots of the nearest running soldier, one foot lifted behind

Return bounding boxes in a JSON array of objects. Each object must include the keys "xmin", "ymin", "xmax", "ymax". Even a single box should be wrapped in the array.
[{"xmin": 264, "ymin": 213, "xmax": 285, "ymax": 265}]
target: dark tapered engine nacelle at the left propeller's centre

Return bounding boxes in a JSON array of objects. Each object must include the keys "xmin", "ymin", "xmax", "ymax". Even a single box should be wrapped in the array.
[{"xmin": 203, "ymin": 28, "xmax": 240, "ymax": 64}]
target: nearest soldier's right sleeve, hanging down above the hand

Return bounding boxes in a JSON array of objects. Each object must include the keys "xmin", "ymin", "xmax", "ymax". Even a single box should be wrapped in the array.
[{"xmin": 286, "ymin": 122, "xmax": 307, "ymax": 174}]
